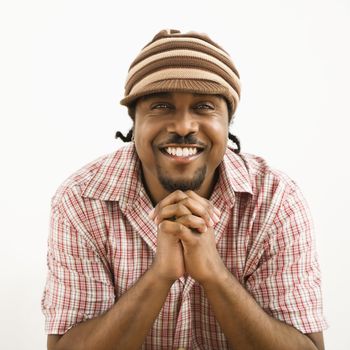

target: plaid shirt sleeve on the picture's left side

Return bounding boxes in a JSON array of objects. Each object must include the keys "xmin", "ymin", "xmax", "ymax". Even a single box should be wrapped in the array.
[{"xmin": 41, "ymin": 204, "xmax": 115, "ymax": 334}]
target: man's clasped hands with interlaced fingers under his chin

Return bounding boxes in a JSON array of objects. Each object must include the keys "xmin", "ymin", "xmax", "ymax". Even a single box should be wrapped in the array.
[{"xmin": 149, "ymin": 190, "xmax": 226, "ymax": 284}]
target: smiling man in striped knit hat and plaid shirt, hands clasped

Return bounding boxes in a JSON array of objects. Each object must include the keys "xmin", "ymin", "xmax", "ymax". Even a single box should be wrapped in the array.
[{"xmin": 42, "ymin": 30, "xmax": 326, "ymax": 350}]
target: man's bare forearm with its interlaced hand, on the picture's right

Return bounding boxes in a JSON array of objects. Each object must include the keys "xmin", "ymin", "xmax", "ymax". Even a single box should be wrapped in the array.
[{"xmin": 153, "ymin": 191, "xmax": 324, "ymax": 350}]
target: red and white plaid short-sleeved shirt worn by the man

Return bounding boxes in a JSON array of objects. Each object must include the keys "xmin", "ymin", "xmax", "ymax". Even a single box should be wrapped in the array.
[{"xmin": 42, "ymin": 145, "xmax": 327, "ymax": 350}]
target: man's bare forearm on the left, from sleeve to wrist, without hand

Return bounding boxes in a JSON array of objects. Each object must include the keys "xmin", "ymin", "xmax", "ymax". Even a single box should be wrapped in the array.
[{"xmin": 47, "ymin": 267, "xmax": 172, "ymax": 350}]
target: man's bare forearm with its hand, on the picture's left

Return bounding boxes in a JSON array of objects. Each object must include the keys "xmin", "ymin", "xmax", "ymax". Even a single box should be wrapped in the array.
[{"xmin": 47, "ymin": 194, "xmax": 191, "ymax": 350}]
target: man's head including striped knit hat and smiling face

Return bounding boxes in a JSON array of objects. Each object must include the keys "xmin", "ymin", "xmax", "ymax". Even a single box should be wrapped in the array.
[{"xmin": 117, "ymin": 30, "xmax": 240, "ymax": 201}]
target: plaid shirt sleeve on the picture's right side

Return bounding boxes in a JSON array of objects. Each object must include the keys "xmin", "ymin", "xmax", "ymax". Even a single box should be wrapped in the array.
[{"xmin": 246, "ymin": 183, "xmax": 328, "ymax": 334}]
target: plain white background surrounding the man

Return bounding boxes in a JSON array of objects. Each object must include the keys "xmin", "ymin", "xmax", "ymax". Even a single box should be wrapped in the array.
[{"xmin": 0, "ymin": 0, "xmax": 350, "ymax": 350}]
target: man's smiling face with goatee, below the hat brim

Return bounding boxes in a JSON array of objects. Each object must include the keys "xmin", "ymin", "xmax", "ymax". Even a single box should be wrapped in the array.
[{"xmin": 134, "ymin": 93, "xmax": 229, "ymax": 202}]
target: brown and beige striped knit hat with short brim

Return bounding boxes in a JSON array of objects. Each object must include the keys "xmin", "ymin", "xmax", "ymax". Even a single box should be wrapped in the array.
[{"xmin": 120, "ymin": 29, "xmax": 241, "ymax": 115}]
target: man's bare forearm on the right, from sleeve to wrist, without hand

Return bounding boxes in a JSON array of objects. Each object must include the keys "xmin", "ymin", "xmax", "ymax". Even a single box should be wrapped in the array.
[{"xmin": 202, "ymin": 268, "xmax": 324, "ymax": 350}]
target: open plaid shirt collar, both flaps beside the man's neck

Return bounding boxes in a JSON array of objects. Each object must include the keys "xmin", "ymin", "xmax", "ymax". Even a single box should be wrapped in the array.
[{"xmin": 82, "ymin": 144, "xmax": 252, "ymax": 208}]
